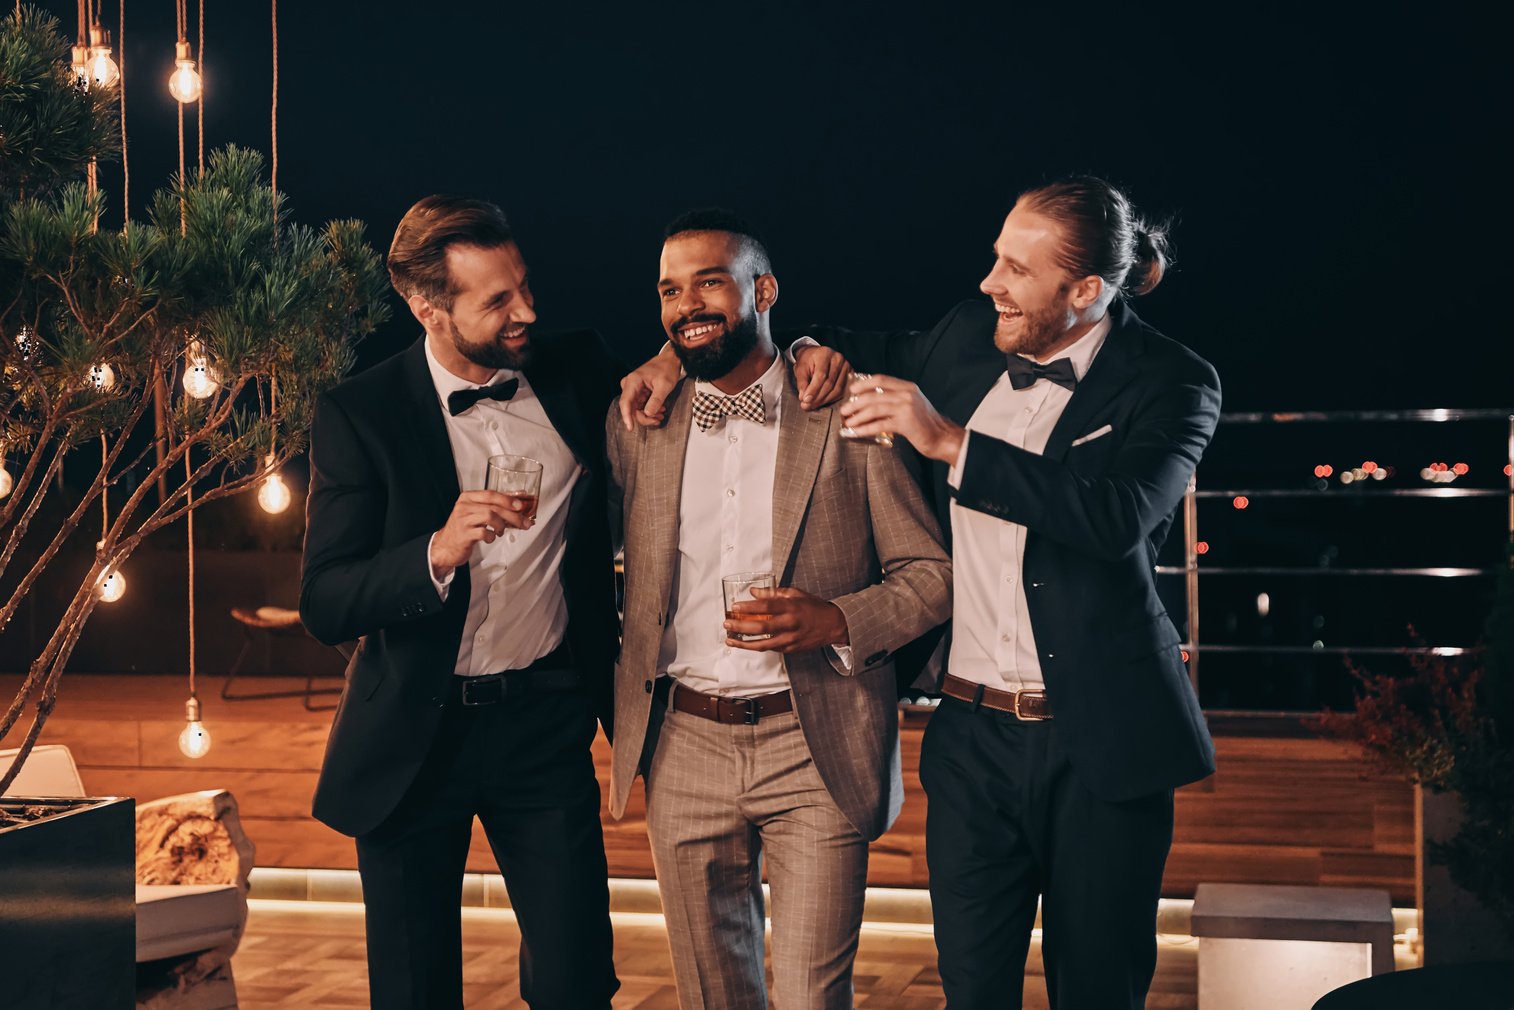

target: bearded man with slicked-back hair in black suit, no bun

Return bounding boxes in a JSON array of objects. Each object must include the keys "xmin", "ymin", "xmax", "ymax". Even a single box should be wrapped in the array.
[{"xmin": 300, "ymin": 197, "xmax": 621, "ymax": 1010}]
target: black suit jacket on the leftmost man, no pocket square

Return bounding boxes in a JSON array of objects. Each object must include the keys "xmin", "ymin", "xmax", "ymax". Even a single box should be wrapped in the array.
[{"xmin": 300, "ymin": 332, "xmax": 622, "ymax": 836}]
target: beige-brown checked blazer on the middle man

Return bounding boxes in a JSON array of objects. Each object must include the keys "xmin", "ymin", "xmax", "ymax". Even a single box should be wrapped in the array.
[{"xmin": 606, "ymin": 371, "xmax": 951, "ymax": 839}]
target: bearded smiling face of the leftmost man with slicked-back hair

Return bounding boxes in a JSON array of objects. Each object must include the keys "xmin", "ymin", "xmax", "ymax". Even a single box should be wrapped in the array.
[{"xmin": 426, "ymin": 242, "xmax": 536, "ymax": 373}]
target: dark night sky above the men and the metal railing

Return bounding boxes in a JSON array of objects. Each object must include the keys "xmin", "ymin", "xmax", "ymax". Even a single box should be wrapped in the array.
[{"xmin": 29, "ymin": 0, "xmax": 1514, "ymax": 410}]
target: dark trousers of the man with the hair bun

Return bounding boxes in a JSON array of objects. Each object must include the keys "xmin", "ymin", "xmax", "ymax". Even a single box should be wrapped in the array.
[{"xmin": 921, "ymin": 698, "xmax": 1172, "ymax": 1010}]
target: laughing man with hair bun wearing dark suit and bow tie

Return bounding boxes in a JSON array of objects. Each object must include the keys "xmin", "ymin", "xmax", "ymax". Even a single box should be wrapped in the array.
[{"xmin": 821, "ymin": 177, "xmax": 1220, "ymax": 1010}]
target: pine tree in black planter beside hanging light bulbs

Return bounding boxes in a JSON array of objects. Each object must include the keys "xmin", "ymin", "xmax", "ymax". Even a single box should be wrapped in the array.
[{"xmin": 0, "ymin": 9, "xmax": 386, "ymax": 1007}]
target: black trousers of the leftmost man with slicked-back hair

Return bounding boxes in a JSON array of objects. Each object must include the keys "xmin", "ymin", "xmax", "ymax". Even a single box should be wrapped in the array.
[{"xmin": 357, "ymin": 690, "xmax": 619, "ymax": 1010}]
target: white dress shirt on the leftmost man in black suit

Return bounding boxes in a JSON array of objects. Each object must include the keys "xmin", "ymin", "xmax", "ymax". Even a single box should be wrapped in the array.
[{"xmin": 425, "ymin": 339, "xmax": 581, "ymax": 677}]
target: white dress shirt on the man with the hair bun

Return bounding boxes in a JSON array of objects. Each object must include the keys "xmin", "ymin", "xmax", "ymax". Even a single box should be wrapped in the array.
[{"xmin": 948, "ymin": 315, "xmax": 1113, "ymax": 690}]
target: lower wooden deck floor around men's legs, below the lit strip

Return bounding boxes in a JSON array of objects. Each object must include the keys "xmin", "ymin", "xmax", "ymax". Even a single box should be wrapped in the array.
[{"xmin": 233, "ymin": 901, "xmax": 1198, "ymax": 1010}]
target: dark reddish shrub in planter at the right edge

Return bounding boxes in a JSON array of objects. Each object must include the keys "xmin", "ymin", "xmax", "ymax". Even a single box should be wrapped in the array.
[{"xmin": 1317, "ymin": 545, "xmax": 1514, "ymax": 965}]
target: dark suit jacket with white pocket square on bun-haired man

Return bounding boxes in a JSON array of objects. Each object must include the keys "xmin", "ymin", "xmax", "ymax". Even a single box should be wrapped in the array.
[{"xmin": 810, "ymin": 300, "xmax": 1220, "ymax": 800}]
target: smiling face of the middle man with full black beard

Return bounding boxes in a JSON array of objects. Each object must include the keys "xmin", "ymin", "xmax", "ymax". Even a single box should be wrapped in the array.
[{"xmin": 657, "ymin": 232, "xmax": 778, "ymax": 385}]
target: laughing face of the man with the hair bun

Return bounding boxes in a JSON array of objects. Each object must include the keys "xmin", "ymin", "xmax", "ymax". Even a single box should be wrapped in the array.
[{"xmin": 978, "ymin": 204, "xmax": 1102, "ymax": 359}]
